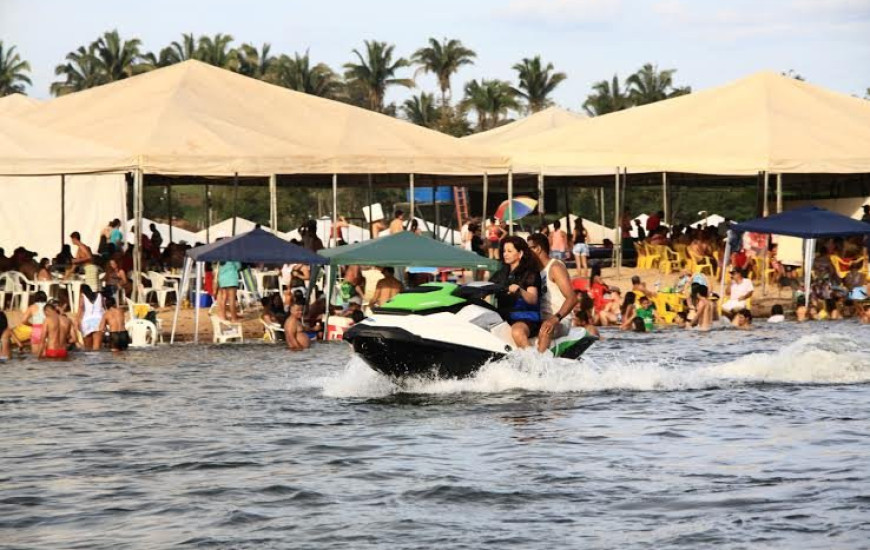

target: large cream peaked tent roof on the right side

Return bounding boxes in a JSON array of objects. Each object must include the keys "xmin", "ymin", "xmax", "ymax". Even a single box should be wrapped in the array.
[{"xmin": 508, "ymin": 72, "xmax": 870, "ymax": 175}]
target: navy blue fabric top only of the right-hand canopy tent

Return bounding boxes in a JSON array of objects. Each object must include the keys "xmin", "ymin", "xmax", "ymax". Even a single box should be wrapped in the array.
[{"xmin": 733, "ymin": 206, "xmax": 870, "ymax": 239}]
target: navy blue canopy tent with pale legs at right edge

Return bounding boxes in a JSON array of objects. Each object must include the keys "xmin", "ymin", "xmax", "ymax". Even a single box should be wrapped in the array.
[{"xmin": 722, "ymin": 206, "xmax": 870, "ymax": 305}]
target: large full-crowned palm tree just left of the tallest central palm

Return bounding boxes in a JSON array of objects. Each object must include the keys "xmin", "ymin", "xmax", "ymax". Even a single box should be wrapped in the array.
[{"xmin": 344, "ymin": 40, "xmax": 414, "ymax": 112}]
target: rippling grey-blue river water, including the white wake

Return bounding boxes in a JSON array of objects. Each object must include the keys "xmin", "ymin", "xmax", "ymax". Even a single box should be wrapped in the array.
[{"xmin": 0, "ymin": 322, "xmax": 870, "ymax": 549}]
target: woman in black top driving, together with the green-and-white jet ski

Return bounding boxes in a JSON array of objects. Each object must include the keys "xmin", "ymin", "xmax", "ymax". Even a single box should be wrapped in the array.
[{"xmin": 344, "ymin": 239, "xmax": 595, "ymax": 378}]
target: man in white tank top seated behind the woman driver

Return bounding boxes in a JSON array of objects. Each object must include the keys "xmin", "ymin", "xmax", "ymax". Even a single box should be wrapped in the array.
[{"xmin": 528, "ymin": 233, "xmax": 577, "ymax": 353}]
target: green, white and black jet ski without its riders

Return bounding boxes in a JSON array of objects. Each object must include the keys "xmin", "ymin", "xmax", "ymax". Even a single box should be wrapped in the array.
[{"xmin": 344, "ymin": 283, "xmax": 597, "ymax": 378}]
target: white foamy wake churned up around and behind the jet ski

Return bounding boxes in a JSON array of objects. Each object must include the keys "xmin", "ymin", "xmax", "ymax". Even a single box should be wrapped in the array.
[{"xmin": 322, "ymin": 334, "xmax": 870, "ymax": 397}]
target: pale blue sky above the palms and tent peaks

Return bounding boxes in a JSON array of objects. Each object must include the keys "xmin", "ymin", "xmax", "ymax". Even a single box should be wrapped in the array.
[{"xmin": 0, "ymin": 0, "xmax": 870, "ymax": 111}]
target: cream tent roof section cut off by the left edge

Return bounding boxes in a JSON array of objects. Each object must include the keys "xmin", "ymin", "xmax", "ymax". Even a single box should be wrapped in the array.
[{"xmin": 0, "ymin": 116, "xmax": 135, "ymax": 176}]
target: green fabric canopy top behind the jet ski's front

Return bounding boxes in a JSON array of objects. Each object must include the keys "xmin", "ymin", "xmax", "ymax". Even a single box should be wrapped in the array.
[{"xmin": 320, "ymin": 231, "xmax": 499, "ymax": 270}]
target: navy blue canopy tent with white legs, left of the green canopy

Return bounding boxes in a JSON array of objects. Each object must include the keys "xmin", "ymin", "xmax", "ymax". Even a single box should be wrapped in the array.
[{"xmin": 170, "ymin": 227, "xmax": 329, "ymax": 342}]
